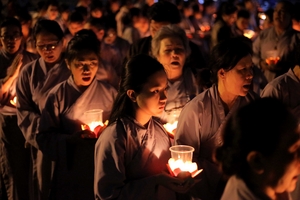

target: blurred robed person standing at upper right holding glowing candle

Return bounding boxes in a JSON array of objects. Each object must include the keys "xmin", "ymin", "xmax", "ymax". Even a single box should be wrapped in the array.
[{"xmin": 253, "ymin": 1, "xmax": 300, "ymax": 82}]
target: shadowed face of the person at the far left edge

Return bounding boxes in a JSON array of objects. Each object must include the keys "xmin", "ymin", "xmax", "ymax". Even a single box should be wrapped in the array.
[{"xmin": 0, "ymin": 26, "xmax": 22, "ymax": 54}]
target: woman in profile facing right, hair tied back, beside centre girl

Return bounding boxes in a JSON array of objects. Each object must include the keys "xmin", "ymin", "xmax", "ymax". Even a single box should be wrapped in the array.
[{"xmin": 175, "ymin": 38, "xmax": 259, "ymax": 200}]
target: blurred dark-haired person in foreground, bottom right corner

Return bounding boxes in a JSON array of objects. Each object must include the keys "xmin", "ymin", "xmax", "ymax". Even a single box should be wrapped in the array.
[{"xmin": 215, "ymin": 98, "xmax": 300, "ymax": 200}]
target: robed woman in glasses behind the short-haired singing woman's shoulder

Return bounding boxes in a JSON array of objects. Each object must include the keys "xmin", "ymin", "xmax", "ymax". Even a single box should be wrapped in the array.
[{"xmin": 16, "ymin": 20, "xmax": 70, "ymax": 199}]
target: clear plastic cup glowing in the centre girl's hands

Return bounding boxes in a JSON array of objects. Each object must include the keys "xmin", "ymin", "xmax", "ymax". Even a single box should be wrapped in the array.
[{"xmin": 169, "ymin": 145, "xmax": 195, "ymax": 163}]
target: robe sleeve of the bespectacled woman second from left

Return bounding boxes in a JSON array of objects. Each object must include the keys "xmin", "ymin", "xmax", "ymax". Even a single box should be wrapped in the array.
[{"xmin": 16, "ymin": 70, "xmax": 40, "ymax": 148}]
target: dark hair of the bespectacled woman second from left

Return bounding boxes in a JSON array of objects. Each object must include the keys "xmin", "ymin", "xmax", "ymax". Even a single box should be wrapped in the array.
[{"xmin": 33, "ymin": 19, "xmax": 64, "ymax": 40}]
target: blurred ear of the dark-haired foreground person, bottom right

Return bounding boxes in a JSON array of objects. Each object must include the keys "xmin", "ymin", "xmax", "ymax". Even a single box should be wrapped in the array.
[{"xmin": 247, "ymin": 151, "xmax": 264, "ymax": 174}]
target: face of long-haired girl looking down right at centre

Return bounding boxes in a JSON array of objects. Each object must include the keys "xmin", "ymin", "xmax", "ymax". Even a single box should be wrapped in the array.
[{"xmin": 136, "ymin": 70, "xmax": 168, "ymax": 116}]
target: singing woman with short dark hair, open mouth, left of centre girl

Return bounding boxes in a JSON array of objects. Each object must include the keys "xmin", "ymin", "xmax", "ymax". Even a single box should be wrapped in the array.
[{"xmin": 37, "ymin": 29, "xmax": 117, "ymax": 200}]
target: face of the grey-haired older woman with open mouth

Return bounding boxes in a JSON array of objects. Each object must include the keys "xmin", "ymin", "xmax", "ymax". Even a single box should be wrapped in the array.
[{"xmin": 157, "ymin": 38, "xmax": 186, "ymax": 72}]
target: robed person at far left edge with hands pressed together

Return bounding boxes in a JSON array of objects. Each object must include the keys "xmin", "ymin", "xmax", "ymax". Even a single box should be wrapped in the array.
[{"xmin": 0, "ymin": 18, "xmax": 37, "ymax": 200}]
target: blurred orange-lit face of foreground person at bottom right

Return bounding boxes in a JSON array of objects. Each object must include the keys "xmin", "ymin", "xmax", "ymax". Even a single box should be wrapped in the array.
[{"xmin": 265, "ymin": 126, "xmax": 300, "ymax": 193}]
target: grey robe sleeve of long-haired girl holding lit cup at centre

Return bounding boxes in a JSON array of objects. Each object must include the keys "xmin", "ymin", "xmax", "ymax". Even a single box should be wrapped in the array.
[{"xmin": 94, "ymin": 124, "xmax": 156, "ymax": 200}]
